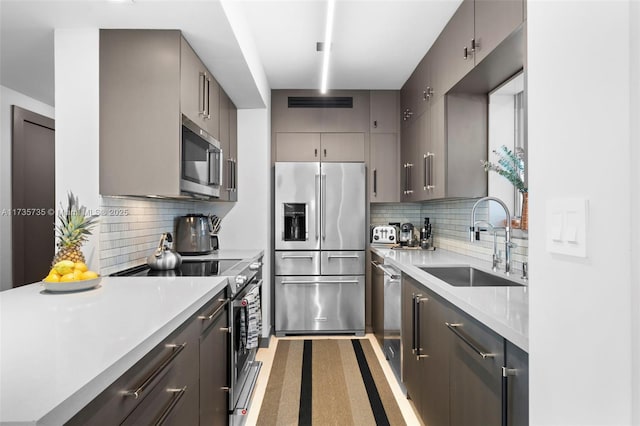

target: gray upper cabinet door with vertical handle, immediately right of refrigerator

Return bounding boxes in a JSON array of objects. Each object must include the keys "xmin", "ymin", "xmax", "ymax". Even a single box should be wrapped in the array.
[{"xmin": 369, "ymin": 133, "xmax": 400, "ymax": 203}]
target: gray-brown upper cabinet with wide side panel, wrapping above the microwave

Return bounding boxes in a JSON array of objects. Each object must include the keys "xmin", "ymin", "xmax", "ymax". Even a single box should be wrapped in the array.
[{"xmin": 99, "ymin": 30, "xmax": 228, "ymax": 197}]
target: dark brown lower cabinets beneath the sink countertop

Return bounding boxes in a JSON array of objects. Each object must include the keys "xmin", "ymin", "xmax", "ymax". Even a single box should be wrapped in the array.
[{"xmin": 402, "ymin": 274, "xmax": 529, "ymax": 426}]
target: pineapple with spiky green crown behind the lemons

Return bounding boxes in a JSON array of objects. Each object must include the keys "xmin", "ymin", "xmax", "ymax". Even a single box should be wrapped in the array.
[{"xmin": 51, "ymin": 192, "xmax": 97, "ymax": 266}]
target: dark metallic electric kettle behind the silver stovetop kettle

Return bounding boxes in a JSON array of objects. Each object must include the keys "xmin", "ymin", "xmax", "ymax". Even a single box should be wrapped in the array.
[{"xmin": 176, "ymin": 214, "xmax": 218, "ymax": 256}]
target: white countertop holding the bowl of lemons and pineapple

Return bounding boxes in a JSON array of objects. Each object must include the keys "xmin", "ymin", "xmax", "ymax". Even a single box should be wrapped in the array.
[{"xmin": 0, "ymin": 277, "xmax": 227, "ymax": 425}]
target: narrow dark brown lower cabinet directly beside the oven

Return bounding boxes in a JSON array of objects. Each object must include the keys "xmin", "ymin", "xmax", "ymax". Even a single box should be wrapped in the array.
[{"xmin": 199, "ymin": 294, "xmax": 230, "ymax": 425}]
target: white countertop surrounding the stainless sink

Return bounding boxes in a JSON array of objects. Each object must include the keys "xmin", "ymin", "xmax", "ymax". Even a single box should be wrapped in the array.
[{"xmin": 372, "ymin": 247, "xmax": 529, "ymax": 352}]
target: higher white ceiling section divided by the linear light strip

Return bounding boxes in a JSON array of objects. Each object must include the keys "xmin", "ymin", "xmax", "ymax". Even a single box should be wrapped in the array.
[{"xmin": 242, "ymin": 0, "xmax": 461, "ymax": 89}]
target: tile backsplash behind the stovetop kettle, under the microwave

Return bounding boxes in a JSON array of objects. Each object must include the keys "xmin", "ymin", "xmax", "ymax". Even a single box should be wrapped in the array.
[{"xmin": 100, "ymin": 197, "xmax": 212, "ymax": 275}]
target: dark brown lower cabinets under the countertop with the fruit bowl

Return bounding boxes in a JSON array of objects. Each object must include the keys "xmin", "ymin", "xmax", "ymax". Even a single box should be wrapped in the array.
[{"xmin": 67, "ymin": 291, "xmax": 229, "ymax": 426}]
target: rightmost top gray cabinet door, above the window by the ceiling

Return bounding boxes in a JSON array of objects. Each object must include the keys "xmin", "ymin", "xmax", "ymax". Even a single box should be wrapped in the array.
[{"xmin": 474, "ymin": 0, "xmax": 524, "ymax": 65}]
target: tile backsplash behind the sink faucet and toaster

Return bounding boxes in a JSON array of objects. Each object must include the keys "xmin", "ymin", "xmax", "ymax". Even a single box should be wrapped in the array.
[{"xmin": 370, "ymin": 199, "xmax": 529, "ymax": 270}]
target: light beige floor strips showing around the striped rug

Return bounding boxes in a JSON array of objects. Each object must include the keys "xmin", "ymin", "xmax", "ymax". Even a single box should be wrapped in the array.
[{"xmin": 246, "ymin": 334, "xmax": 422, "ymax": 426}]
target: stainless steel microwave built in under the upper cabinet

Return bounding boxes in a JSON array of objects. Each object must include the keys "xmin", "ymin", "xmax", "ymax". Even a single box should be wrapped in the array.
[{"xmin": 180, "ymin": 115, "xmax": 223, "ymax": 197}]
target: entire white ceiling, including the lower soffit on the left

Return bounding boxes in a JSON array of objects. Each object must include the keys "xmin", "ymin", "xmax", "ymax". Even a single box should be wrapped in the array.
[{"xmin": 0, "ymin": 0, "xmax": 461, "ymax": 108}]
